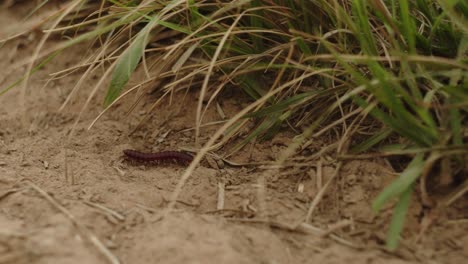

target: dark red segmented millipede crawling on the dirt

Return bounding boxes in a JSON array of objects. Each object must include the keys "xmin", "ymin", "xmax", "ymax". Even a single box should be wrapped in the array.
[{"xmin": 123, "ymin": 149, "xmax": 193, "ymax": 164}]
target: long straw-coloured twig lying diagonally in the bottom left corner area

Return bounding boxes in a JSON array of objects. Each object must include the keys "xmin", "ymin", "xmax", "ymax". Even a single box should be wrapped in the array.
[{"xmin": 25, "ymin": 180, "xmax": 120, "ymax": 264}]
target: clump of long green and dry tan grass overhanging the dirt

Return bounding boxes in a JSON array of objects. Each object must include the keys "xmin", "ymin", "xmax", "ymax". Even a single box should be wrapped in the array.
[{"xmin": 0, "ymin": 0, "xmax": 468, "ymax": 250}]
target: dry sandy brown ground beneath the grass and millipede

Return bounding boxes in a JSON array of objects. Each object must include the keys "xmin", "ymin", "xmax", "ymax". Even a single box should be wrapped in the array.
[{"xmin": 0, "ymin": 4, "xmax": 468, "ymax": 264}]
